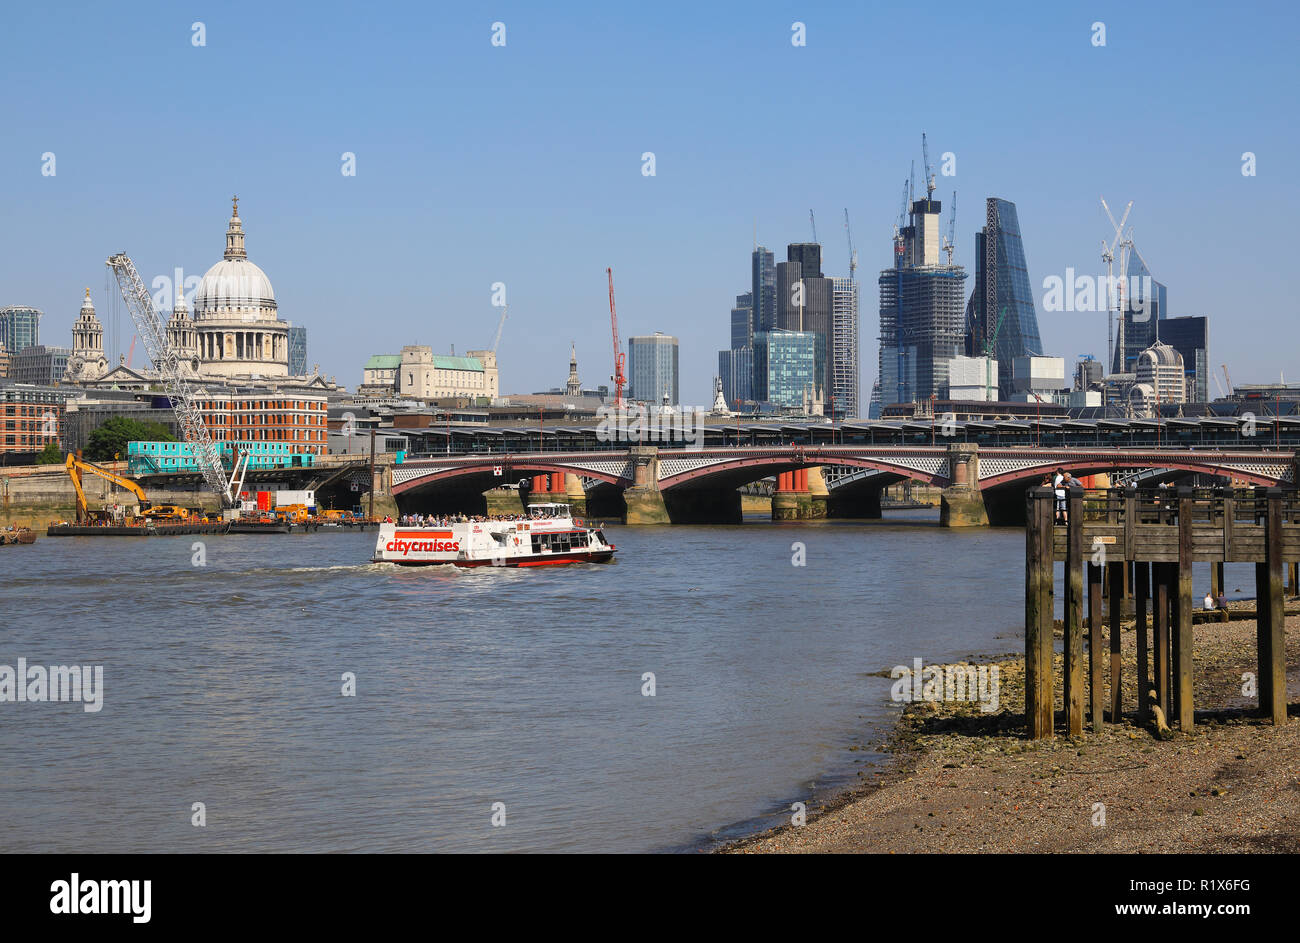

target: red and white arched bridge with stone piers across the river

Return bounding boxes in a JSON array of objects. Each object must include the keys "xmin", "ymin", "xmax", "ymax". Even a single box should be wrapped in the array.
[{"xmin": 391, "ymin": 442, "xmax": 1297, "ymax": 527}]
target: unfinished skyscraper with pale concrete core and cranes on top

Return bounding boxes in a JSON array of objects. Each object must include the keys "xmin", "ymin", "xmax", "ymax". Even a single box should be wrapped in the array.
[{"xmin": 879, "ymin": 192, "xmax": 966, "ymax": 405}]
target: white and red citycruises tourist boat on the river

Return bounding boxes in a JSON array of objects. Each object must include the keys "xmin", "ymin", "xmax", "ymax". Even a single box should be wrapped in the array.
[{"xmin": 373, "ymin": 505, "xmax": 615, "ymax": 567}]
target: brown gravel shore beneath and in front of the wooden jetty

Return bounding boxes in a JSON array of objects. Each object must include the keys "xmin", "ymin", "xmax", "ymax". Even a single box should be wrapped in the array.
[{"xmin": 719, "ymin": 604, "xmax": 1300, "ymax": 855}]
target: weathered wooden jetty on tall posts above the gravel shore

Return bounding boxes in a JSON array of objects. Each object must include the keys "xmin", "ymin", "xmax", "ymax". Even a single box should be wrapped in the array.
[{"xmin": 1024, "ymin": 488, "xmax": 1300, "ymax": 739}]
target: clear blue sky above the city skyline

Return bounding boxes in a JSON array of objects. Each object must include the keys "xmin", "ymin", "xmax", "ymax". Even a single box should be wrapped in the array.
[{"xmin": 0, "ymin": 0, "xmax": 1300, "ymax": 403}]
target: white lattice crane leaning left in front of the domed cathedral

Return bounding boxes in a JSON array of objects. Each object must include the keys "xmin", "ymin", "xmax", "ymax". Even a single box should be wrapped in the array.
[{"xmin": 107, "ymin": 252, "xmax": 248, "ymax": 509}]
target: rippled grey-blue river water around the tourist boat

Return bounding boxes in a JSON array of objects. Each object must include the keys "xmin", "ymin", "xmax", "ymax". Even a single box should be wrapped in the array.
[{"xmin": 0, "ymin": 511, "xmax": 1024, "ymax": 852}]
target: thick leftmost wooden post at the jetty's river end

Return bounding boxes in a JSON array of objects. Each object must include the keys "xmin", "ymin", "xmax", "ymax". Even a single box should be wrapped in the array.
[{"xmin": 1024, "ymin": 488, "xmax": 1056, "ymax": 740}]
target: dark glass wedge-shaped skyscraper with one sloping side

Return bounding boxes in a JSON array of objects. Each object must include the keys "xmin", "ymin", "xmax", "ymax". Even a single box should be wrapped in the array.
[{"xmin": 966, "ymin": 196, "xmax": 1043, "ymax": 399}]
